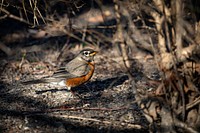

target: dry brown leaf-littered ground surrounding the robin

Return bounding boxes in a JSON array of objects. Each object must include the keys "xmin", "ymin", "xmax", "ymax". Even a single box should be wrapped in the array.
[{"xmin": 0, "ymin": 42, "xmax": 158, "ymax": 133}]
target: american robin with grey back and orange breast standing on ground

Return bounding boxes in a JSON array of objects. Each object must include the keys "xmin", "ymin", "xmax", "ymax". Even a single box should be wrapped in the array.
[{"xmin": 23, "ymin": 49, "xmax": 97, "ymax": 94}]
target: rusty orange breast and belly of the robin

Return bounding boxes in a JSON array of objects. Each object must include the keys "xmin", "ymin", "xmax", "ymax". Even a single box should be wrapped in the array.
[{"xmin": 66, "ymin": 63, "xmax": 94, "ymax": 87}]
